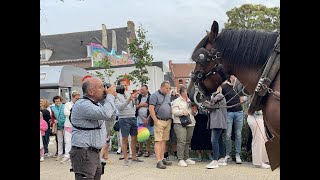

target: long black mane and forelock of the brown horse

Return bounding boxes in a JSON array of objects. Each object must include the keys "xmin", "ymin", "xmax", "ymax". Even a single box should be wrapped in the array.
[{"xmin": 215, "ymin": 29, "xmax": 278, "ymax": 67}]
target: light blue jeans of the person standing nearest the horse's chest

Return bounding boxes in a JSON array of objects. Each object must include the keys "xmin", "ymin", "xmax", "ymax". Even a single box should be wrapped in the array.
[{"xmin": 226, "ymin": 111, "xmax": 243, "ymax": 155}]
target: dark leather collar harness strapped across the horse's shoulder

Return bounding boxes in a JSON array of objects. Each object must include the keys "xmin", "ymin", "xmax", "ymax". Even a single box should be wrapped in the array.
[{"xmin": 248, "ymin": 34, "xmax": 280, "ymax": 114}]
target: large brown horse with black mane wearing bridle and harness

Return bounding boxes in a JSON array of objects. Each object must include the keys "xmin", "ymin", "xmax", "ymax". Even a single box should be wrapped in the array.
[{"xmin": 188, "ymin": 21, "xmax": 280, "ymax": 170}]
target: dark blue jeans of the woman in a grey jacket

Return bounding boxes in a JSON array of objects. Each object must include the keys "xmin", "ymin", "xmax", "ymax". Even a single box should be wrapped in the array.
[{"xmin": 211, "ymin": 129, "xmax": 224, "ymax": 160}]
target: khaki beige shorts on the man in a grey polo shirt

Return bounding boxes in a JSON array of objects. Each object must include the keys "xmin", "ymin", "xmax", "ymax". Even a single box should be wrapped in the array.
[{"xmin": 154, "ymin": 120, "xmax": 172, "ymax": 141}]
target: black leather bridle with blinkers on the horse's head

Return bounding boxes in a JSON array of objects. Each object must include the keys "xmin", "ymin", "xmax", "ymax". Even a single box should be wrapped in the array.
[{"xmin": 191, "ymin": 47, "xmax": 230, "ymax": 105}]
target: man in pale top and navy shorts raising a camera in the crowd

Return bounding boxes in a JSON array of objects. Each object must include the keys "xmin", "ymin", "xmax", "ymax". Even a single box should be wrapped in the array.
[{"xmin": 115, "ymin": 79, "xmax": 143, "ymax": 166}]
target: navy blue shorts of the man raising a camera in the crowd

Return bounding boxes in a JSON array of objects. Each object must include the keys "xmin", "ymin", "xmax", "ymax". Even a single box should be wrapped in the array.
[{"xmin": 119, "ymin": 117, "xmax": 138, "ymax": 138}]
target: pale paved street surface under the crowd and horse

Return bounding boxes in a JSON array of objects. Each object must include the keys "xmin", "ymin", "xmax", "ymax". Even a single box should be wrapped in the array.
[{"xmin": 40, "ymin": 137, "xmax": 280, "ymax": 180}]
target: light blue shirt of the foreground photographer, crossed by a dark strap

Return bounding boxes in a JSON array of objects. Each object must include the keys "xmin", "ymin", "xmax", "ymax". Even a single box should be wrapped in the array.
[{"xmin": 71, "ymin": 94, "xmax": 116, "ymax": 149}]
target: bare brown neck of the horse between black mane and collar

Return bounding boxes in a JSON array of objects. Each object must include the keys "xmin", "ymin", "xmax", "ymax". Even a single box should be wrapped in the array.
[{"xmin": 232, "ymin": 67, "xmax": 262, "ymax": 94}]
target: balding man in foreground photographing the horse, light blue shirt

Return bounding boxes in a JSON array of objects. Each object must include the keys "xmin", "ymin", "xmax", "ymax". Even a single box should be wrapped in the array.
[{"xmin": 69, "ymin": 77, "xmax": 117, "ymax": 180}]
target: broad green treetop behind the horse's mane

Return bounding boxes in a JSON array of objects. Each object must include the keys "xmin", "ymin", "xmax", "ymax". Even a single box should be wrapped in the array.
[{"xmin": 224, "ymin": 4, "xmax": 280, "ymax": 31}]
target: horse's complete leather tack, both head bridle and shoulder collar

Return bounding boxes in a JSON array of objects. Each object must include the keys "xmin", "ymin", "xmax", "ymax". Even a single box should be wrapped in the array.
[{"xmin": 191, "ymin": 34, "xmax": 280, "ymax": 114}]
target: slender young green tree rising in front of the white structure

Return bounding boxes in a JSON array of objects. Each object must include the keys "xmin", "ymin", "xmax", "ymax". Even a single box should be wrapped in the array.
[{"xmin": 128, "ymin": 25, "xmax": 153, "ymax": 85}]
